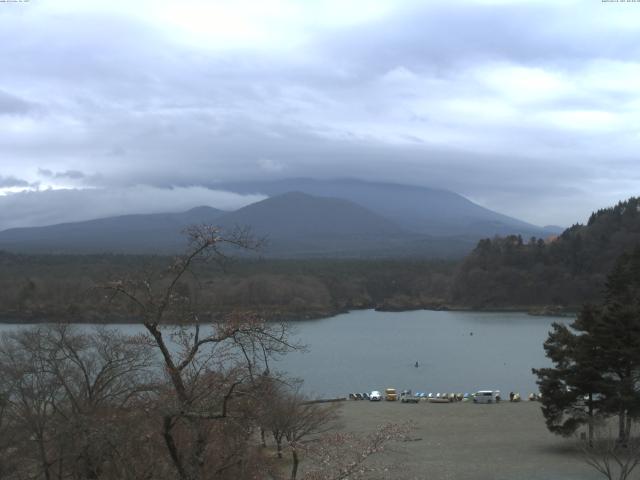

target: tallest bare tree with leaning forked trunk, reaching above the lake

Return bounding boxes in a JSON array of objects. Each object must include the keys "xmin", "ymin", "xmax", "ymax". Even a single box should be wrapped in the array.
[{"xmin": 105, "ymin": 226, "xmax": 295, "ymax": 480}]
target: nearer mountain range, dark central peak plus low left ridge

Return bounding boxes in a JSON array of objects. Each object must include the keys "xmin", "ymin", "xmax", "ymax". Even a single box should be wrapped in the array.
[{"xmin": 0, "ymin": 192, "xmax": 474, "ymax": 258}]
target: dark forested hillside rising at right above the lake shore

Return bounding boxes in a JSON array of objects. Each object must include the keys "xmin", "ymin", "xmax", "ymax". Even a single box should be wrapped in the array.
[{"xmin": 451, "ymin": 198, "xmax": 640, "ymax": 308}]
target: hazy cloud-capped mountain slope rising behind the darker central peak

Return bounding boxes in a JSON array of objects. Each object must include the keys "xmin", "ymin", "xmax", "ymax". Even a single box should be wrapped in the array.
[{"xmin": 218, "ymin": 178, "xmax": 559, "ymax": 240}]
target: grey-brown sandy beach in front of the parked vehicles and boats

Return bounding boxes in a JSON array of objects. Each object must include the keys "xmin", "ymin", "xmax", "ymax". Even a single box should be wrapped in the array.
[{"xmin": 332, "ymin": 401, "xmax": 602, "ymax": 480}]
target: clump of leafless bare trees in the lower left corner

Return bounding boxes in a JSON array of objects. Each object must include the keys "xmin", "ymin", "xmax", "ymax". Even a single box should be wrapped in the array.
[{"xmin": 0, "ymin": 325, "xmax": 153, "ymax": 479}]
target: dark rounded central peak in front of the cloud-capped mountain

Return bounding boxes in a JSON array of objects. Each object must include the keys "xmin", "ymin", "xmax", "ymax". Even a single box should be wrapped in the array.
[{"xmin": 212, "ymin": 192, "xmax": 472, "ymax": 258}]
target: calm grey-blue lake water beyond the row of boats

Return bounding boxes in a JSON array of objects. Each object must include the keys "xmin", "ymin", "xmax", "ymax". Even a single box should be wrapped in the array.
[{"xmin": 0, "ymin": 310, "xmax": 570, "ymax": 397}]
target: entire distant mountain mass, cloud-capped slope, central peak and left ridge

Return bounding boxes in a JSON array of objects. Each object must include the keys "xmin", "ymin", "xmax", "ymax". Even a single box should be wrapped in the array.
[{"xmin": 0, "ymin": 183, "xmax": 560, "ymax": 258}]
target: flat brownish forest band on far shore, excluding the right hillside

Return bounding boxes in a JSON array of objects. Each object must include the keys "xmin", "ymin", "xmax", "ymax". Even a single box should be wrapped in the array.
[{"xmin": 0, "ymin": 253, "xmax": 457, "ymax": 322}]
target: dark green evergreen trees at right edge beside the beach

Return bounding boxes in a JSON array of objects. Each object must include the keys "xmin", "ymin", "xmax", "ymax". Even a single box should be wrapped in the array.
[{"xmin": 534, "ymin": 248, "xmax": 640, "ymax": 443}]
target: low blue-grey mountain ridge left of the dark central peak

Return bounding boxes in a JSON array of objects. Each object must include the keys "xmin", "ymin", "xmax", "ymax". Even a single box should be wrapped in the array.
[{"xmin": 0, "ymin": 207, "xmax": 225, "ymax": 253}]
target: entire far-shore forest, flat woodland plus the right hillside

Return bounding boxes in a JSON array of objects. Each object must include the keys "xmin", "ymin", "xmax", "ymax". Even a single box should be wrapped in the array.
[{"xmin": 0, "ymin": 198, "xmax": 640, "ymax": 321}]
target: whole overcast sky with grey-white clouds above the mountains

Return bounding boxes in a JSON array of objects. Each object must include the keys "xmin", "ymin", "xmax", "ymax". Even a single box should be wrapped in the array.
[{"xmin": 0, "ymin": 0, "xmax": 640, "ymax": 229}]
